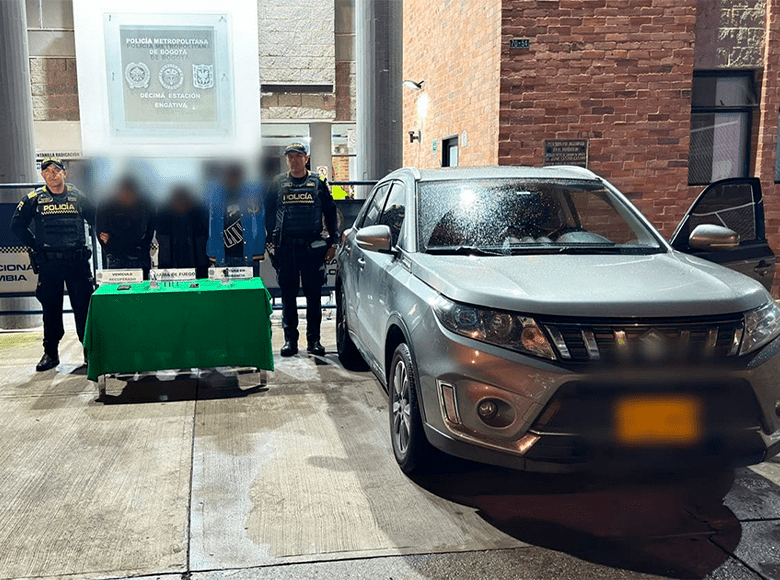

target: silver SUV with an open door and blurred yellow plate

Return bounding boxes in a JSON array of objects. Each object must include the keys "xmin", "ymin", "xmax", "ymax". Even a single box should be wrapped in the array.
[{"xmin": 337, "ymin": 167, "xmax": 780, "ymax": 473}]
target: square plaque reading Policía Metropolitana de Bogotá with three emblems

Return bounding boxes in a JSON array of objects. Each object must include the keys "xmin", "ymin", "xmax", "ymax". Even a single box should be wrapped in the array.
[{"xmin": 105, "ymin": 14, "xmax": 233, "ymax": 136}]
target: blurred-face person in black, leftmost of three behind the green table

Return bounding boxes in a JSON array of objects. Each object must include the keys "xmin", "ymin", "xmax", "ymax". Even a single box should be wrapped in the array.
[{"xmin": 96, "ymin": 177, "xmax": 154, "ymax": 280}]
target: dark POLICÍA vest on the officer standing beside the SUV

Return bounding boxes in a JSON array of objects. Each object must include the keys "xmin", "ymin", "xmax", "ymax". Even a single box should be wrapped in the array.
[{"xmin": 276, "ymin": 171, "xmax": 322, "ymax": 239}]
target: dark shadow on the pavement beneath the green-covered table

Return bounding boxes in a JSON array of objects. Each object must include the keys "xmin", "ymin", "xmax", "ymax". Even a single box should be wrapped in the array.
[{"xmin": 100, "ymin": 370, "xmax": 268, "ymax": 405}]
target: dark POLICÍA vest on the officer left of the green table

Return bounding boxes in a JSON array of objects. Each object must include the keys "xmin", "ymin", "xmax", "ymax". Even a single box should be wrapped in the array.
[{"xmin": 33, "ymin": 185, "xmax": 87, "ymax": 250}]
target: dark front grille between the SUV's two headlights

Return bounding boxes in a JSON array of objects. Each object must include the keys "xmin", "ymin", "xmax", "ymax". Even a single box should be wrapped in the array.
[{"xmin": 542, "ymin": 317, "xmax": 743, "ymax": 362}]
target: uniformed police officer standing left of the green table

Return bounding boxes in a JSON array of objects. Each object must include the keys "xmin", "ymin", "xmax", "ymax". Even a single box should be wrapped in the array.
[{"xmin": 11, "ymin": 158, "xmax": 95, "ymax": 371}]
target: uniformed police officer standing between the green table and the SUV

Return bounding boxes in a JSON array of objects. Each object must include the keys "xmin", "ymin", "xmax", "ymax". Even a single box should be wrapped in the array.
[{"xmin": 265, "ymin": 143, "xmax": 338, "ymax": 356}]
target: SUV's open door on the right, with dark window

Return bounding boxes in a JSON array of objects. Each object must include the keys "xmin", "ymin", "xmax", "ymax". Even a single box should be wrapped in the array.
[{"xmin": 671, "ymin": 177, "xmax": 775, "ymax": 290}]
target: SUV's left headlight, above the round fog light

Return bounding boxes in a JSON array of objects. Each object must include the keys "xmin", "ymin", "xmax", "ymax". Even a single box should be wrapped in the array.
[{"xmin": 433, "ymin": 296, "xmax": 555, "ymax": 360}]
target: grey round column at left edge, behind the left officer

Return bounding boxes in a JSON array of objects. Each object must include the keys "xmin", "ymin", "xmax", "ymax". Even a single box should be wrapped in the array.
[{"xmin": 0, "ymin": 0, "xmax": 41, "ymax": 328}]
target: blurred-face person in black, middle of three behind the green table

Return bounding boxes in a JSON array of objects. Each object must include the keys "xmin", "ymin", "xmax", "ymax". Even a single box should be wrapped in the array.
[{"xmin": 156, "ymin": 186, "xmax": 209, "ymax": 278}]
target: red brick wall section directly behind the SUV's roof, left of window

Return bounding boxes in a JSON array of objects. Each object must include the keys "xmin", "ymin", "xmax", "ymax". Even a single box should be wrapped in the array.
[{"xmin": 498, "ymin": 0, "xmax": 696, "ymax": 235}]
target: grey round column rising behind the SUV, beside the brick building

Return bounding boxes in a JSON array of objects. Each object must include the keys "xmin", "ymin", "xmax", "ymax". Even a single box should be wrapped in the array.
[{"xmin": 355, "ymin": 0, "xmax": 403, "ymax": 197}]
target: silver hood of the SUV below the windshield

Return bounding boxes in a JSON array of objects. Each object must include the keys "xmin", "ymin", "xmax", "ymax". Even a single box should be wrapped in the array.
[{"xmin": 408, "ymin": 251, "xmax": 771, "ymax": 318}]
